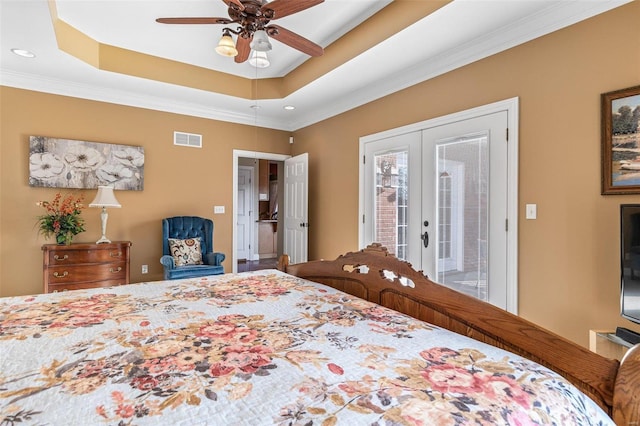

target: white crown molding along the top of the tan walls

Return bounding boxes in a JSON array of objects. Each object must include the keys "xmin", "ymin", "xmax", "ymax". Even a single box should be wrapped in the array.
[{"xmin": 0, "ymin": 0, "xmax": 632, "ymax": 131}]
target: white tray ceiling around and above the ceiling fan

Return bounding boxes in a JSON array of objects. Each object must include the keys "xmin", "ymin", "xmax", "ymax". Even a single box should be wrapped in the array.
[{"xmin": 0, "ymin": 0, "xmax": 631, "ymax": 131}]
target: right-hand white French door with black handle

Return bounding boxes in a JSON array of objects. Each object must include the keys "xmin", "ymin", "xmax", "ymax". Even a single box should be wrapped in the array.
[{"xmin": 420, "ymin": 111, "xmax": 508, "ymax": 308}]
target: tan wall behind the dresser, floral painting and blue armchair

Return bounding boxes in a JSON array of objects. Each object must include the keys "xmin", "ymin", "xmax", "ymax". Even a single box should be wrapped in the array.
[{"xmin": 0, "ymin": 87, "xmax": 291, "ymax": 296}]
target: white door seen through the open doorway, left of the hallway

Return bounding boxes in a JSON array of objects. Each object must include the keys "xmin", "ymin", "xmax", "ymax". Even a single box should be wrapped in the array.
[{"xmin": 236, "ymin": 166, "xmax": 255, "ymax": 260}]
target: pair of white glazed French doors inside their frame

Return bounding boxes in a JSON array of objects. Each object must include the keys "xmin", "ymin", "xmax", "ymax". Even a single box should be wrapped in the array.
[{"xmin": 361, "ymin": 101, "xmax": 516, "ymax": 311}]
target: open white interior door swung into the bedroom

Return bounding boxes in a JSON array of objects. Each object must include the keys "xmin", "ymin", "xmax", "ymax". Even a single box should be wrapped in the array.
[{"xmin": 283, "ymin": 153, "xmax": 309, "ymax": 263}]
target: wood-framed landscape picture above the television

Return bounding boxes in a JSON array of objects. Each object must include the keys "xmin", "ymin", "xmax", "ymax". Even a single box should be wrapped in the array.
[{"xmin": 601, "ymin": 86, "xmax": 640, "ymax": 195}]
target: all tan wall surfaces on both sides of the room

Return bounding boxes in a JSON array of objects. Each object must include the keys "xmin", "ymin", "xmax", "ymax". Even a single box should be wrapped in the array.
[{"xmin": 0, "ymin": 2, "xmax": 640, "ymax": 345}]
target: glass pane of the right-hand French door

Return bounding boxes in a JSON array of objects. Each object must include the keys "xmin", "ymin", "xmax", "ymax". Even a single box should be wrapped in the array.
[{"xmin": 436, "ymin": 134, "xmax": 489, "ymax": 300}]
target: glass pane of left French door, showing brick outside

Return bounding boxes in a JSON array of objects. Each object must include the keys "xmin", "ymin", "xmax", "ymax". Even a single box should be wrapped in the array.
[{"xmin": 374, "ymin": 151, "xmax": 409, "ymax": 260}]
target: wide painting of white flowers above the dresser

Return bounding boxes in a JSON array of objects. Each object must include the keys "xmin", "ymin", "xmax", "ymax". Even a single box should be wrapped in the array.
[{"xmin": 29, "ymin": 136, "xmax": 144, "ymax": 191}]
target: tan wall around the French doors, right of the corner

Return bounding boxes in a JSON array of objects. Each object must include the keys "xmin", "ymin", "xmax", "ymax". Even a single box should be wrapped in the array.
[{"xmin": 294, "ymin": 2, "xmax": 640, "ymax": 345}]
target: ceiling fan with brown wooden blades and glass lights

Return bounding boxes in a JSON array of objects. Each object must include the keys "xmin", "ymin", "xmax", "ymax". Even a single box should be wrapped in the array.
[{"xmin": 156, "ymin": 0, "xmax": 324, "ymax": 63}]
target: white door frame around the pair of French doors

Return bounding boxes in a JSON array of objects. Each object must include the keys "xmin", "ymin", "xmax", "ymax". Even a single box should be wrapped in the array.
[{"xmin": 358, "ymin": 97, "xmax": 519, "ymax": 315}]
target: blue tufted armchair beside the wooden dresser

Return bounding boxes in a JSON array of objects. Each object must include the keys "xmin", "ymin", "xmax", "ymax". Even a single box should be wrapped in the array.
[{"xmin": 160, "ymin": 216, "xmax": 225, "ymax": 280}]
